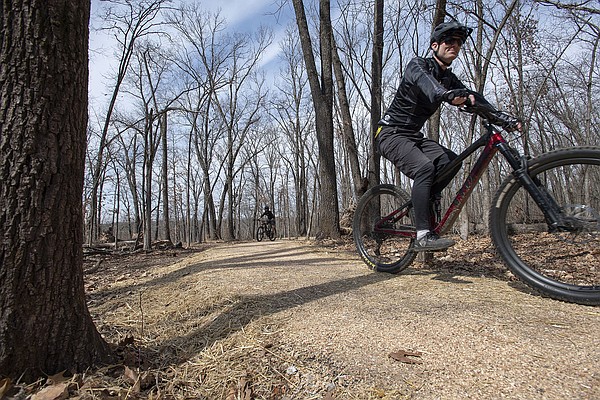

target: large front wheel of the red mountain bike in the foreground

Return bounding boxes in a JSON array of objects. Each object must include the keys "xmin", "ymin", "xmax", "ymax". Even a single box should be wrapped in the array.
[{"xmin": 490, "ymin": 147, "xmax": 600, "ymax": 305}]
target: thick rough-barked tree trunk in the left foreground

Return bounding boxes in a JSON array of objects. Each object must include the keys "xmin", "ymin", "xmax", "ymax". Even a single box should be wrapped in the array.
[{"xmin": 0, "ymin": 0, "xmax": 110, "ymax": 380}]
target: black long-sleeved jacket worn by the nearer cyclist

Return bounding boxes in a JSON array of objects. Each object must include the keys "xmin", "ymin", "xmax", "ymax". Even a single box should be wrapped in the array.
[{"xmin": 379, "ymin": 57, "xmax": 489, "ymax": 137}]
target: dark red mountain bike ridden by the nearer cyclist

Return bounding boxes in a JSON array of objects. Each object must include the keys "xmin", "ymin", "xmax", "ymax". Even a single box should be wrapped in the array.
[{"xmin": 352, "ymin": 106, "xmax": 600, "ymax": 305}]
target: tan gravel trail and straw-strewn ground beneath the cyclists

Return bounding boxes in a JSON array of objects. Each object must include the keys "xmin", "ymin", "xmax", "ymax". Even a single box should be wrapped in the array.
[{"xmin": 10, "ymin": 238, "xmax": 600, "ymax": 400}]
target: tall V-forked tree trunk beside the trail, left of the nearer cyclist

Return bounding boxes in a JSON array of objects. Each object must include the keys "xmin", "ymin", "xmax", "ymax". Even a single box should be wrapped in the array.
[{"xmin": 293, "ymin": 0, "xmax": 340, "ymax": 239}]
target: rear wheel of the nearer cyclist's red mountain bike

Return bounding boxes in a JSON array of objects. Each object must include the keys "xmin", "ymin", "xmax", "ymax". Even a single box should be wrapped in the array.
[{"xmin": 352, "ymin": 185, "xmax": 416, "ymax": 273}]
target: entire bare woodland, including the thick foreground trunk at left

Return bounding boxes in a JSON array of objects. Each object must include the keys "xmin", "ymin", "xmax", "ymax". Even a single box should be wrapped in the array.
[{"xmin": 0, "ymin": 0, "xmax": 600, "ymax": 380}]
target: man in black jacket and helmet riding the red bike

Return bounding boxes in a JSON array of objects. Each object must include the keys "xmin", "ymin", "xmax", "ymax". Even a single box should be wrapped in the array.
[{"xmin": 375, "ymin": 21, "xmax": 521, "ymax": 251}]
